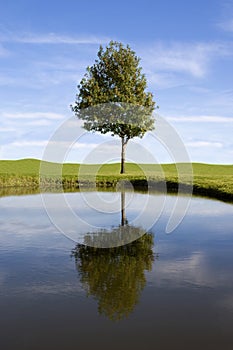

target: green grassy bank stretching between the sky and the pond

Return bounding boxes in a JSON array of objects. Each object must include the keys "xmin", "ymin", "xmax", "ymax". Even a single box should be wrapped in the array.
[{"xmin": 0, "ymin": 159, "xmax": 233, "ymax": 202}]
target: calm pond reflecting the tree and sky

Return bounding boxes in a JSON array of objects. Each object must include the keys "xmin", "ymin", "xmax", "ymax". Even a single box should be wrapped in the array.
[{"xmin": 0, "ymin": 191, "xmax": 233, "ymax": 350}]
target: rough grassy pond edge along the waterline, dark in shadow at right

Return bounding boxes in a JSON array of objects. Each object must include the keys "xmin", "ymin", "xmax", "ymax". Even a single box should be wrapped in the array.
[{"xmin": 0, "ymin": 176, "xmax": 233, "ymax": 203}]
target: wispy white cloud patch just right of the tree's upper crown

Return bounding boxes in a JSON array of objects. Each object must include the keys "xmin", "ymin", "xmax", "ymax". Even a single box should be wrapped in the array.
[{"xmin": 142, "ymin": 42, "xmax": 230, "ymax": 78}]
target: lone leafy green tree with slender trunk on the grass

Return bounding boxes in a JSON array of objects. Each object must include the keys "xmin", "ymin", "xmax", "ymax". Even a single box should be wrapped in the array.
[{"xmin": 71, "ymin": 41, "xmax": 155, "ymax": 174}]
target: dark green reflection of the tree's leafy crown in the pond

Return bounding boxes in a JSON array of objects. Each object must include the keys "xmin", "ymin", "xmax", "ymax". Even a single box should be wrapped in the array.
[{"xmin": 72, "ymin": 233, "xmax": 154, "ymax": 320}]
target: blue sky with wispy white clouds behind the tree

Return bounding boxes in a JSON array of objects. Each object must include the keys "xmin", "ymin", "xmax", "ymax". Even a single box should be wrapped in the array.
[{"xmin": 0, "ymin": 0, "xmax": 233, "ymax": 164}]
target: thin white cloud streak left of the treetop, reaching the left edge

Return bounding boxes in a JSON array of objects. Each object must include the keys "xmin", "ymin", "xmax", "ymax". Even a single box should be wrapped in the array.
[{"xmin": 0, "ymin": 33, "xmax": 110, "ymax": 45}]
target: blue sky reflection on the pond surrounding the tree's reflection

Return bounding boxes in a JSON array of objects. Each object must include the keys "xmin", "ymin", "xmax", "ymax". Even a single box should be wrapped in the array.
[{"xmin": 0, "ymin": 193, "xmax": 233, "ymax": 346}]
